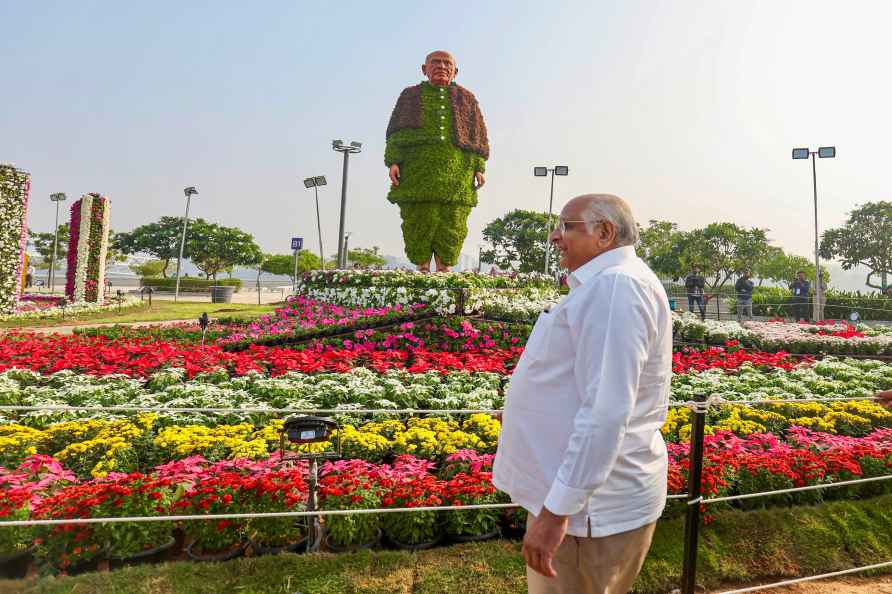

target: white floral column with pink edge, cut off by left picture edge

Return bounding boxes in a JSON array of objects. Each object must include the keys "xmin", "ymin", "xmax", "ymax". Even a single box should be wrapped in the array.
[{"xmin": 0, "ymin": 163, "xmax": 31, "ymax": 314}]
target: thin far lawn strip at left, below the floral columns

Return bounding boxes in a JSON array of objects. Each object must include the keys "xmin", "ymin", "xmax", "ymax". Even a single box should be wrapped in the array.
[{"xmin": 0, "ymin": 299, "xmax": 276, "ymax": 328}]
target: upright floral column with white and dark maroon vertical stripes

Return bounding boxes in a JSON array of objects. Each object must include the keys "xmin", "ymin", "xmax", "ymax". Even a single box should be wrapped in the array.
[{"xmin": 65, "ymin": 193, "xmax": 110, "ymax": 303}]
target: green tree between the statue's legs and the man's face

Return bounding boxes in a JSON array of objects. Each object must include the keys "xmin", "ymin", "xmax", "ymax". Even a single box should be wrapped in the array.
[{"xmin": 480, "ymin": 210, "xmax": 559, "ymax": 272}]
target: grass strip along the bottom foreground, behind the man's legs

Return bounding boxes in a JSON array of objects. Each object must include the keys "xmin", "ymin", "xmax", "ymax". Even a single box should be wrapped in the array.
[{"xmin": 6, "ymin": 495, "xmax": 892, "ymax": 594}]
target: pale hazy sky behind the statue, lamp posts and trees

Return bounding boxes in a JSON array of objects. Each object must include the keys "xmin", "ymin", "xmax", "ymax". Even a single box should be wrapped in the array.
[{"xmin": 0, "ymin": 0, "xmax": 892, "ymax": 284}]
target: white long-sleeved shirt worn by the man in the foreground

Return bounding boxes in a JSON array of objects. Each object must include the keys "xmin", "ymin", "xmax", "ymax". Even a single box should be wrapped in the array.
[{"xmin": 493, "ymin": 246, "xmax": 672, "ymax": 537}]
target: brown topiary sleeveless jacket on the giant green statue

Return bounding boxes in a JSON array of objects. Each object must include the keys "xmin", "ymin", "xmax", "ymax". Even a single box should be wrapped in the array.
[{"xmin": 387, "ymin": 83, "xmax": 489, "ymax": 159}]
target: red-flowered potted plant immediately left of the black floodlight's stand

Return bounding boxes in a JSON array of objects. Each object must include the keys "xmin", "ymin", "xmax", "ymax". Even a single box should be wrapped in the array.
[{"xmin": 242, "ymin": 468, "xmax": 307, "ymax": 555}]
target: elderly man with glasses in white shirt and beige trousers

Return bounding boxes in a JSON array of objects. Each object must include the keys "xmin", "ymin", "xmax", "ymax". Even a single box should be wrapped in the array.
[{"xmin": 493, "ymin": 194, "xmax": 672, "ymax": 594}]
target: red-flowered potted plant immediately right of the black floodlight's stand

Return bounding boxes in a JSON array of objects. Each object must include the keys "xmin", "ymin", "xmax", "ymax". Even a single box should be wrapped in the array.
[{"xmin": 319, "ymin": 460, "xmax": 382, "ymax": 551}]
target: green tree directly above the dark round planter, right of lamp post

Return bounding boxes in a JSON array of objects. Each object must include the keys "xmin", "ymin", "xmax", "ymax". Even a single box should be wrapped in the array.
[{"xmin": 186, "ymin": 219, "xmax": 263, "ymax": 282}]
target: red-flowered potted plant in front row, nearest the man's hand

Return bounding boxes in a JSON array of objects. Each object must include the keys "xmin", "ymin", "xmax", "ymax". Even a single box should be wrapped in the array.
[{"xmin": 443, "ymin": 472, "xmax": 501, "ymax": 542}]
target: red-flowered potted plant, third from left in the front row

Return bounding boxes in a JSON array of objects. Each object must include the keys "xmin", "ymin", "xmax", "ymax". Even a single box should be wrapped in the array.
[{"xmin": 96, "ymin": 475, "xmax": 176, "ymax": 567}]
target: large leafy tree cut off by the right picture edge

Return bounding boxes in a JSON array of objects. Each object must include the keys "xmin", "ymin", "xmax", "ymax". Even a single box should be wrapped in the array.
[{"xmin": 820, "ymin": 201, "xmax": 892, "ymax": 290}]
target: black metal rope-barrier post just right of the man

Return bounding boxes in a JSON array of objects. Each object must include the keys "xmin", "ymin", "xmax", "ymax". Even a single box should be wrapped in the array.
[{"xmin": 681, "ymin": 394, "xmax": 706, "ymax": 594}]
